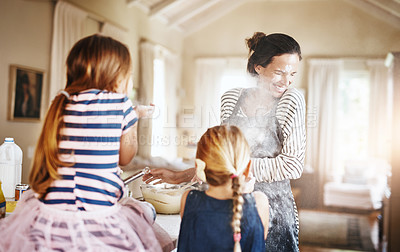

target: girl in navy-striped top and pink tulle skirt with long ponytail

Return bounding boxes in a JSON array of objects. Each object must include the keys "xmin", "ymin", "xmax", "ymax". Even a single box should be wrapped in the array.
[{"xmin": 0, "ymin": 35, "xmax": 161, "ymax": 251}]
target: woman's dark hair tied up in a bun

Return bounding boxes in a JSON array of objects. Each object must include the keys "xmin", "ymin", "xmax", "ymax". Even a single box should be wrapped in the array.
[{"xmin": 246, "ymin": 32, "xmax": 301, "ymax": 75}]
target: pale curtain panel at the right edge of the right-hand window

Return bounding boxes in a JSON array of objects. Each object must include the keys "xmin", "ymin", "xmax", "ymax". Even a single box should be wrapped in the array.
[{"xmin": 367, "ymin": 60, "xmax": 393, "ymax": 161}]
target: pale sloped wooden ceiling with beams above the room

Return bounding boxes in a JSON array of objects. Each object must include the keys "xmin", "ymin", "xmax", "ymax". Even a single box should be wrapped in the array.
[{"xmin": 126, "ymin": 0, "xmax": 400, "ymax": 35}]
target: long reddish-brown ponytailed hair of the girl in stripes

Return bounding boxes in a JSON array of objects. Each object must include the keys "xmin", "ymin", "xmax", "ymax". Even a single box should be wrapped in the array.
[{"xmin": 29, "ymin": 34, "xmax": 132, "ymax": 197}]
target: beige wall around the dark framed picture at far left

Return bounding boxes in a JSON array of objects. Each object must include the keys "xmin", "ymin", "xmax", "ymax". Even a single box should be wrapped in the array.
[{"xmin": 0, "ymin": 0, "xmax": 53, "ymax": 185}]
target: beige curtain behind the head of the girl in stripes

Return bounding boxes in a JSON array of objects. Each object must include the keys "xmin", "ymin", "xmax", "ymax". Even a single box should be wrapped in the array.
[{"xmin": 49, "ymin": 1, "xmax": 88, "ymax": 104}]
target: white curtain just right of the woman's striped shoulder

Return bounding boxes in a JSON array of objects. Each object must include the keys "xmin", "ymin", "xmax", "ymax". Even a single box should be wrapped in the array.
[{"xmin": 305, "ymin": 59, "xmax": 342, "ymax": 203}]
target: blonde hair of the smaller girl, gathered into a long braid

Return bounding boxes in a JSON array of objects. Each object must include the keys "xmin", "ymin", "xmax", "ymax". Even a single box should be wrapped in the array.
[{"xmin": 196, "ymin": 125, "xmax": 250, "ymax": 252}]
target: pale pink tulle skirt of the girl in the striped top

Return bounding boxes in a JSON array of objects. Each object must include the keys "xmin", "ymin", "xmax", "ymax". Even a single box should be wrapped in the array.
[{"xmin": 0, "ymin": 190, "xmax": 162, "ymax": 252}]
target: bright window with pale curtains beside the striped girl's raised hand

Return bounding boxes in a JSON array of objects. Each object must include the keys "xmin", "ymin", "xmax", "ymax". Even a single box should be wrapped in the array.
[{"xmin": 139, "ymin": 42, "xmax": 181, "ymax": 160}]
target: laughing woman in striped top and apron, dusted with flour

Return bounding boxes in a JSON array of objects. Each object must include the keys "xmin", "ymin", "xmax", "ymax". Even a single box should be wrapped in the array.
[{"xmin": 221, "ymin": 32, "xmax": 306, "ymax": 252}]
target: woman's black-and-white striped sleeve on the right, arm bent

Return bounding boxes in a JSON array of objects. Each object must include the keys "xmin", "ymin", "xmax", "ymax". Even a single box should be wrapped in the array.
[{"xmin": 251, "ymin": 89, "xmax": 306, "ymax": 182}]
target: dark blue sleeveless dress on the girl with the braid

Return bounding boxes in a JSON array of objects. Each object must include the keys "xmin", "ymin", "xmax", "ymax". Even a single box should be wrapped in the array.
[{"xmin": 178, "ymin": 190, "xmax": 265, "ymax": 252}]
